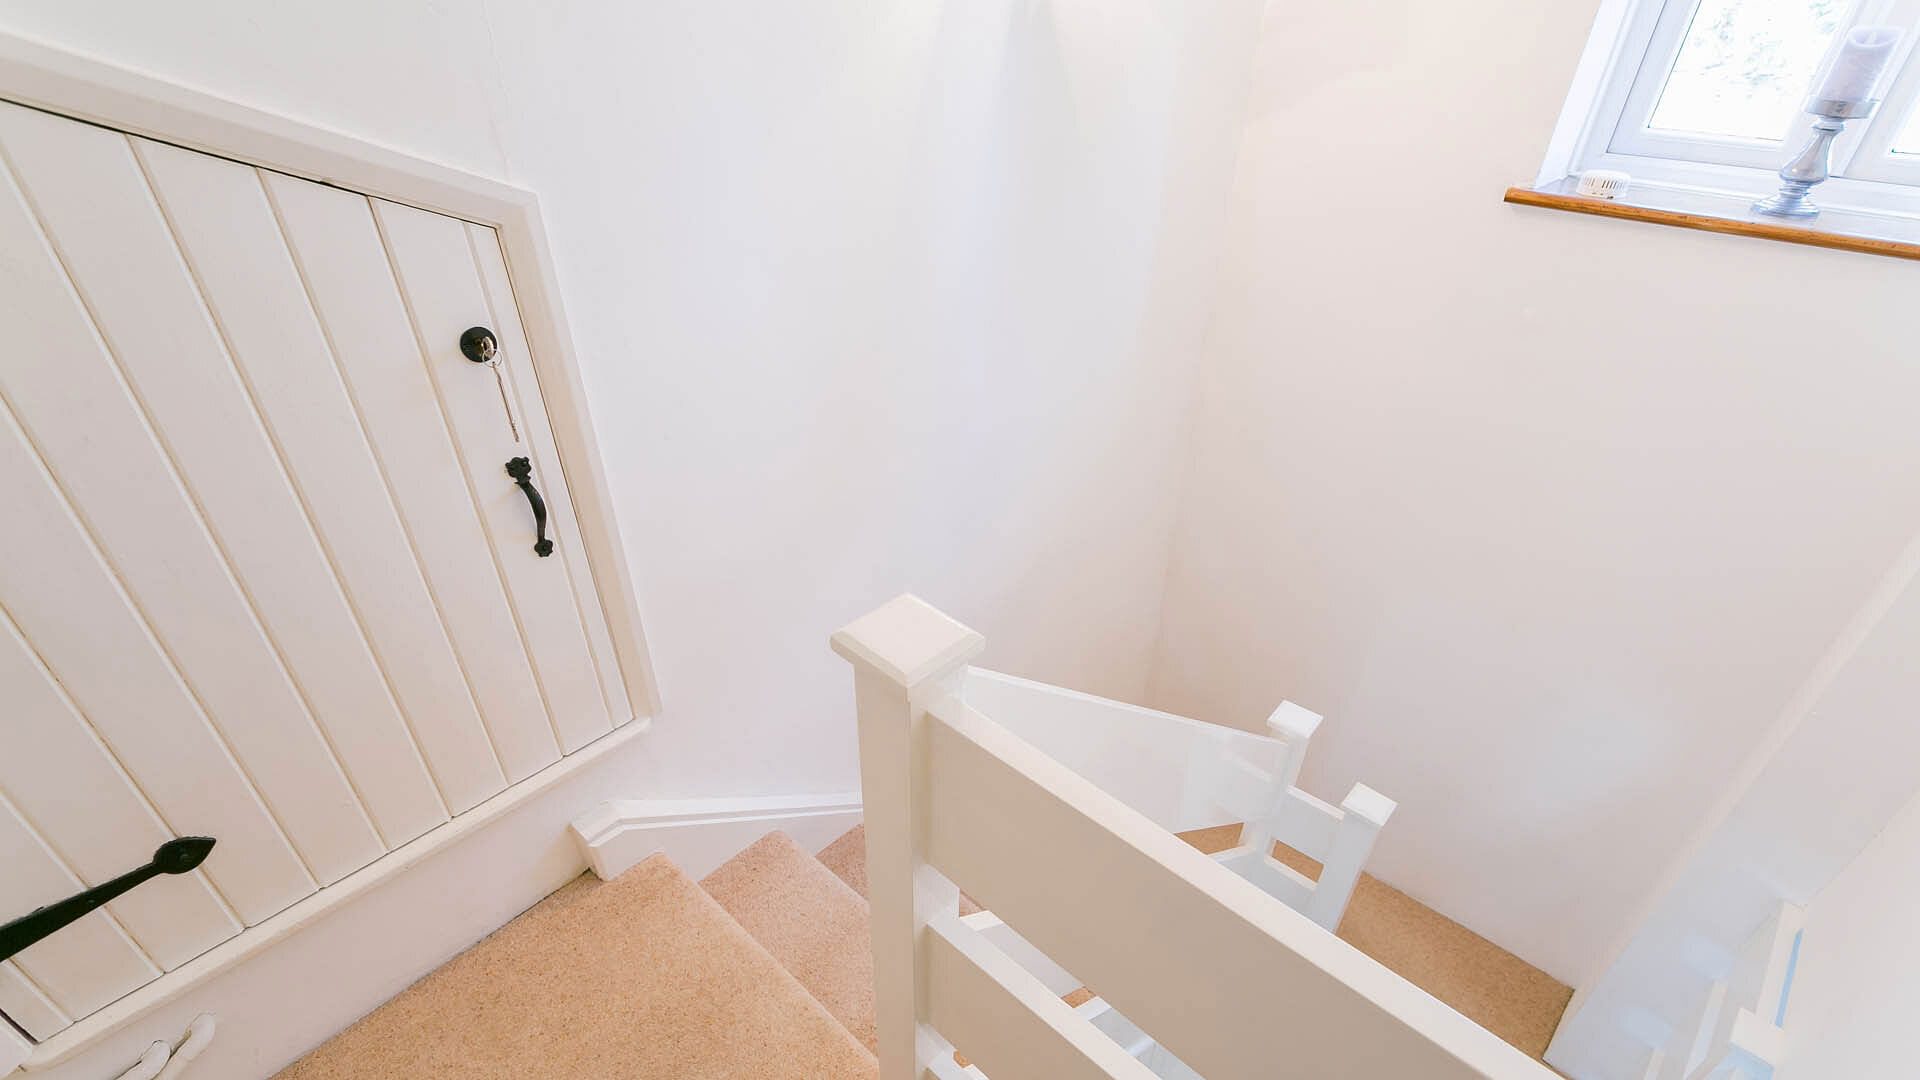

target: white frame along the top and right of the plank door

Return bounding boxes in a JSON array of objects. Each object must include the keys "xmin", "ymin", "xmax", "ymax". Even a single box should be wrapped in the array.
[{"xmin": 0, "ymin": 33, "xmax": 660, "ymax": 721}]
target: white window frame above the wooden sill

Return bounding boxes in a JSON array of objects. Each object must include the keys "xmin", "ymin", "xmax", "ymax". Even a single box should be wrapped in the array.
[{"xmin": 1542, "ymin": 0, "xmax": 1920, "ymax": 219}]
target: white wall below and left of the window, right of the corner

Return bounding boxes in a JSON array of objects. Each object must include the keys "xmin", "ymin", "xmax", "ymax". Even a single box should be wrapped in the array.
[{"xmin": 1152, "ymin": 0, "xmax": 1920, "ymax": 984}]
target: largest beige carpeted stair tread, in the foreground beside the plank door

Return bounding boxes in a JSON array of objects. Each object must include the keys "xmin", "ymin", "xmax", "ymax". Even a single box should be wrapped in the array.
[{"xmin": 280, "ymin": 855, "xmax": 876, "ymax": 1080}]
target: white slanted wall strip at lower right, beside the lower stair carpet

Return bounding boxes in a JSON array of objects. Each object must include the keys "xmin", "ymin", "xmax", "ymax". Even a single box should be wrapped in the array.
[{"xmin": 1548, "ymin": 536, "xmax": 1920, "ymax": 1080}]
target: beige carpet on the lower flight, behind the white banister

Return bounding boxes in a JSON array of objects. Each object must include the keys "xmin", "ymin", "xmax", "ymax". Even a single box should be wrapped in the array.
[{"xmin": 1181, "ymin": 824, "xmax": 1572, "ymax": 1059}]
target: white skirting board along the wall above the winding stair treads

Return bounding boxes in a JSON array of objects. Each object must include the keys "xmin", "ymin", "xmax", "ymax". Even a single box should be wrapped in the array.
[{"xmin": 572, "ymin": 792, "xmax": 860, "ymax": 880}]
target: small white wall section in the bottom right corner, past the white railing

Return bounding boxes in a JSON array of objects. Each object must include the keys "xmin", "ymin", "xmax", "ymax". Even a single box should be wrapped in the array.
[{"xmin": 1776, "ymin": 776, "xmax": 1920, "ymax": 1080}]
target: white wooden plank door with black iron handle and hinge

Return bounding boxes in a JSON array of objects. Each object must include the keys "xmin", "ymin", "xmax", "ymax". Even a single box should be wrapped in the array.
[{"xmin": 0, "ymin": 102, "xmax": 632, "ymax": 1040}]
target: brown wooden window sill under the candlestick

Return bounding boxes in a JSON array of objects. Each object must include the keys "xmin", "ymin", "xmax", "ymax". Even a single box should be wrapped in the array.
[{"xmin": 1505, "ymin": 181, "xmax": 1920, "ymax": 259}]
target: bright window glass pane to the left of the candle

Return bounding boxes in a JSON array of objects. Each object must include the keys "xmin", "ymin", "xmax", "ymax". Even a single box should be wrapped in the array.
[{"xmin": 1647, "ymin": 0, "xmax": 1847, "ymax": 142}]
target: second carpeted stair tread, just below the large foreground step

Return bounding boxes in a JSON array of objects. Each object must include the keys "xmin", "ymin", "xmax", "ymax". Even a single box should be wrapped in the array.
[{"xmin": 701, "ymin": 832, "xmax": 874, "ymax": 1049}]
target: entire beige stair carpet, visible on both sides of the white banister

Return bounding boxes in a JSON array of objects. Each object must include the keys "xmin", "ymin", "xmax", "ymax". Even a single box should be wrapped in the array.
[{"xmin": 280, "ymin": 826, "xmax": 1572, "ymax": 1080}]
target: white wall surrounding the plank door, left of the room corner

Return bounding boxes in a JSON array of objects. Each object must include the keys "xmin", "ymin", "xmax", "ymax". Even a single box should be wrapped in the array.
[{"xmin": 0, "ymin": 0, "xmax": 1260, "ymax": 1080}]
